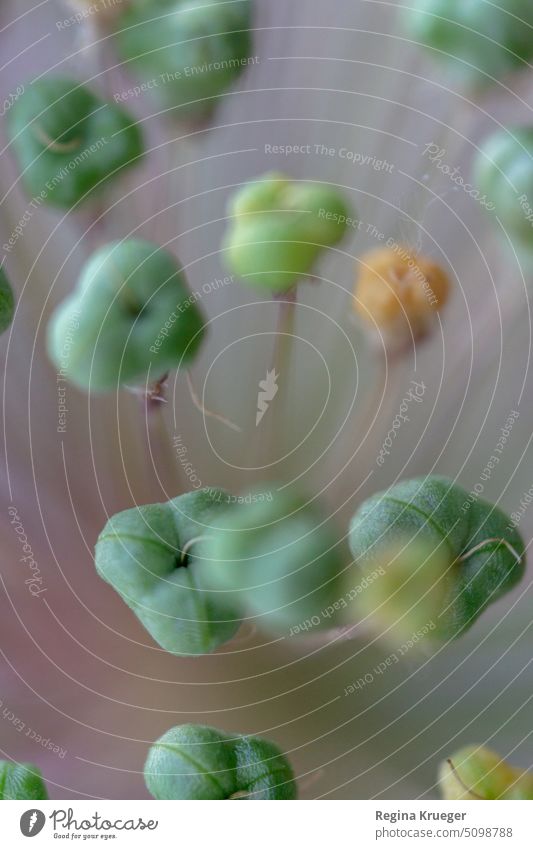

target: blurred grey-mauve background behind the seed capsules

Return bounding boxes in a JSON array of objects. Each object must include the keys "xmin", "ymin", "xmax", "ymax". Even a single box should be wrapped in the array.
[{"xmin": 0, "ymin": 0, "xmax": 533, "ymax": 799}]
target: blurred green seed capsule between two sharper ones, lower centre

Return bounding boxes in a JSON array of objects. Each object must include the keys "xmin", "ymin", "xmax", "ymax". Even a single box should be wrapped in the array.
[{"xmin": 199, "ymin": 492, "xmax": 343, "ymax": 632}]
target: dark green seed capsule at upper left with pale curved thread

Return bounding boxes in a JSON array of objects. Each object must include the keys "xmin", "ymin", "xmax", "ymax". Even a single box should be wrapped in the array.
[{"xmin": 8, "ymin": 76, "xmax": 143, "ymax": 209}]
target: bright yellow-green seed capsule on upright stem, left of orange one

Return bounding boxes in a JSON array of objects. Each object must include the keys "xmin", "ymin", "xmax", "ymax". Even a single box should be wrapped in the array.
[{"xmin": 223, "ymin": 172, "xmax": 354, "ymax": 292}]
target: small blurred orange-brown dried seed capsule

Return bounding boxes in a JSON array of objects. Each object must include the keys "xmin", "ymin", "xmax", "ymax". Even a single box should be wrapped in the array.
[{"xmin": 354, "ymin": 244, "xmax": 450, "ymax": 343}]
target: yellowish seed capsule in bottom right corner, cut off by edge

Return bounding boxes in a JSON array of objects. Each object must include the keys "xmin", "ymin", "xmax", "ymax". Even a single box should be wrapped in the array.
[{"xmin": 439, "ymin": 746, "xmax": 533, "ymax": 802}]
